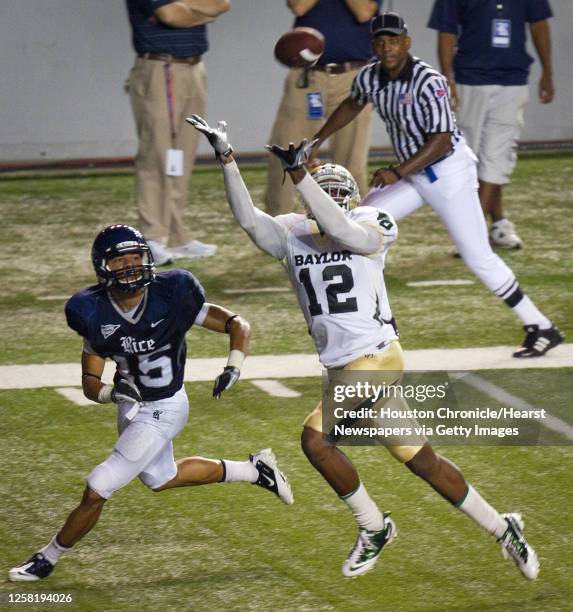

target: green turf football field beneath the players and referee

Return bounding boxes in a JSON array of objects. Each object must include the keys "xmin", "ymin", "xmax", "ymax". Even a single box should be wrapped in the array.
[{"xmin": 0, "ymin": 155, "xmax": 573, "ymax": 611}]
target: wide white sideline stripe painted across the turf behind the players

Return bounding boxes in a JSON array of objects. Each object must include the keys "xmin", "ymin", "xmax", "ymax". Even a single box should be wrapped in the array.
[{"xmin": 0, "ymin": 343, "xmax": 573, "ymax": 389}]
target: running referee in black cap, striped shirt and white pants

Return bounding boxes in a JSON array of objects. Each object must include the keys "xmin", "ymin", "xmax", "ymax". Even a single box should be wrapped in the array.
[{"xmin": 309, "ymin": 13, "xmax": 564, "ymax": 358}]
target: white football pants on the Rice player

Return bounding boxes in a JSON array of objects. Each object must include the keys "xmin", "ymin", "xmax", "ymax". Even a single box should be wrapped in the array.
[{"xmin": 87, "ymin": 387, "xmax": 189, "ymax": 499}]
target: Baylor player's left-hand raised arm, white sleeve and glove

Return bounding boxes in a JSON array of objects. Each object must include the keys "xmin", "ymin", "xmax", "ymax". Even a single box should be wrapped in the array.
[{"xmin": 186, "ymin": 115, "xmax": 287, "ymax": 259}]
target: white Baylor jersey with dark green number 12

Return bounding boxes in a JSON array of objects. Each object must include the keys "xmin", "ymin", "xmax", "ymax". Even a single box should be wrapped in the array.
[{"xmin": 278, "ymin": 196, "xmax": 397, "ymax": 368}]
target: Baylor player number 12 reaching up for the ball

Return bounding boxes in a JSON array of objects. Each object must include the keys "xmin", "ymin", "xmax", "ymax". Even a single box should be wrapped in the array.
[{"xmin": 187, "ymin": 115, "xmax": 539, "ymax": 579}]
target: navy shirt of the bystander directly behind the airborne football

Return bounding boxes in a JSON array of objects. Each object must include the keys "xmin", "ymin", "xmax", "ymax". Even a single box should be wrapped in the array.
[{"xmin": 294, "ymin": 0, "xmax": 382, "ymax": 65}]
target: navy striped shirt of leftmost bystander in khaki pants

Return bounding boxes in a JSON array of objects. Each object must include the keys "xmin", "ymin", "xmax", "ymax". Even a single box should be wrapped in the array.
[{"xmin": 127, "ymin": 0, "xmax": 209, "ymax": 57}]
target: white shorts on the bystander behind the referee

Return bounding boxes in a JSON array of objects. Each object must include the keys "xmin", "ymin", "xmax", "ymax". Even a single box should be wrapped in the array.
[{"xmin": 456, "ymin": 84, "xmax": 529, "ymax": 185}]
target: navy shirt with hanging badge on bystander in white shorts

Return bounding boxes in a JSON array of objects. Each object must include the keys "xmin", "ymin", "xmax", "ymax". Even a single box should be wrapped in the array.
[{"xmin": 428, "ymin": 0, "xmax": 552, "ymax": 85}]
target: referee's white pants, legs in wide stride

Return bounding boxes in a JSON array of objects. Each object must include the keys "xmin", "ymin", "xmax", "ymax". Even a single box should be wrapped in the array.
[{"xmin": 361, "ymin": 142, "xmax": 515, "ymax": 297}]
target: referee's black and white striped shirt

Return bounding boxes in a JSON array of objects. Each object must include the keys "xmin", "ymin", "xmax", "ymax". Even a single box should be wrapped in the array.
[{"xmin": 351, "ymin": 57, "xmax": 461, "ymax": 162}]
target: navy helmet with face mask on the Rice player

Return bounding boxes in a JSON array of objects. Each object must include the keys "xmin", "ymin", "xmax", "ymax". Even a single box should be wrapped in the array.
[{"xmin": 92, "ymin": 225, "xmax": 155, "ymax": 293}]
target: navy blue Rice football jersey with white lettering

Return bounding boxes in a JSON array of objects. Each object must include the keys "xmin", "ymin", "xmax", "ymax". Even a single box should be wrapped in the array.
[{"xmin": 66, "ymin": 270, "xmax": 205, "ymax": 402}]
